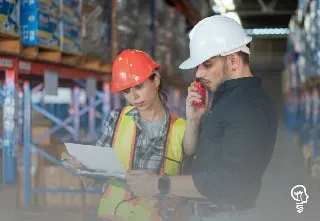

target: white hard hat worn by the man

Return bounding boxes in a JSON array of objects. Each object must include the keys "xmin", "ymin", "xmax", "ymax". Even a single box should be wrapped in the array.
[{"xmin": 179, "ymin": 15, "xmax": 252, "ymax": 69}]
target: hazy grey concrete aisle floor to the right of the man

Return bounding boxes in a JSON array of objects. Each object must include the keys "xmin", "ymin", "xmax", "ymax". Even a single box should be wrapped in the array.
[{"xmin": 257, "ymin": 123, "xmax": 320, "ymax": 221}]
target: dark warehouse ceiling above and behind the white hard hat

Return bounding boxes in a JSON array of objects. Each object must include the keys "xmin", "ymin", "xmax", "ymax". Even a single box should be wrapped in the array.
[{"xmin": 164, "ymin": 0, "xmax": 298, "ymax": 29}]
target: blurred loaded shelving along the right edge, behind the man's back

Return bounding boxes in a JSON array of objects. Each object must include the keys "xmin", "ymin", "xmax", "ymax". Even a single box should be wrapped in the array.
[{"xmin": 283, "ymin": 0, "xmax": 320, "ymax": 181}]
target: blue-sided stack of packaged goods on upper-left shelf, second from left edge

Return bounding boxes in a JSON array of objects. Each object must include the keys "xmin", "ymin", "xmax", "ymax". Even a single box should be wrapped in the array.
[{"xmin": 20, "ymin": 0, "xmax": 82, "ymax": 54}]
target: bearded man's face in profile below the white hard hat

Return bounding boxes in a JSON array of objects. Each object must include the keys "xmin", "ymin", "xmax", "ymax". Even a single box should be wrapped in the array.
[{"xmin": 196, "ymin": 57, "xmax": 228, "ymax": 91}]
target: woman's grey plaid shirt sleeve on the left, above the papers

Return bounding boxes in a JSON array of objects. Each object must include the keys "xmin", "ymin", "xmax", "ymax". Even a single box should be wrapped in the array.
[{"xmin": 96, "ymin": 110, "xmax": 120, "ymax": 147}]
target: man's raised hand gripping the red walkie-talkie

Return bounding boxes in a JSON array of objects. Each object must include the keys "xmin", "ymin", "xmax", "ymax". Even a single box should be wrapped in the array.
[{"xmin": 186, "ymin": 84, "xmax": 208, "ymax": 122}]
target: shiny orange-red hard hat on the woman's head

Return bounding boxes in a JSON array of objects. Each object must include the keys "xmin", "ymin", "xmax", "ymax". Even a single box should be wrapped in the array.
[{"xmin": 111, "ymin": 49, "xmax": 161, "ymax": 93}]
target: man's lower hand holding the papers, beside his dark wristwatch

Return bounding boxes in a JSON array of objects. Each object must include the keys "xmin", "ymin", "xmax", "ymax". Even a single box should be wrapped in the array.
[{"xmin": 126, "ymin": 170, "xmax": 159, "ymax": 198}]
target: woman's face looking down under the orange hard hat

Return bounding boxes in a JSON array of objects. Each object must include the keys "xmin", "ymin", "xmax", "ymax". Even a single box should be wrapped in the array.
[{"xmin": 123, "ymin": 76, "xmax": 160, "ymax": 111}]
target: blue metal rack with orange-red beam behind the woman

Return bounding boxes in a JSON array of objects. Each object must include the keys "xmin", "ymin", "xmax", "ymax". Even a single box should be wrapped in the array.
[{"xmin": 0, "ymin": 0, "xmax": 190, "ymax": 207}]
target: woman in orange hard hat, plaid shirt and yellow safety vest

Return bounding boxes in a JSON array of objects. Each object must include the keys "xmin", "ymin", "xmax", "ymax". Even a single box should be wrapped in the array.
[{"xmin": 63, "ymin": 50, "xmax": 185, "ymax": 221}]
